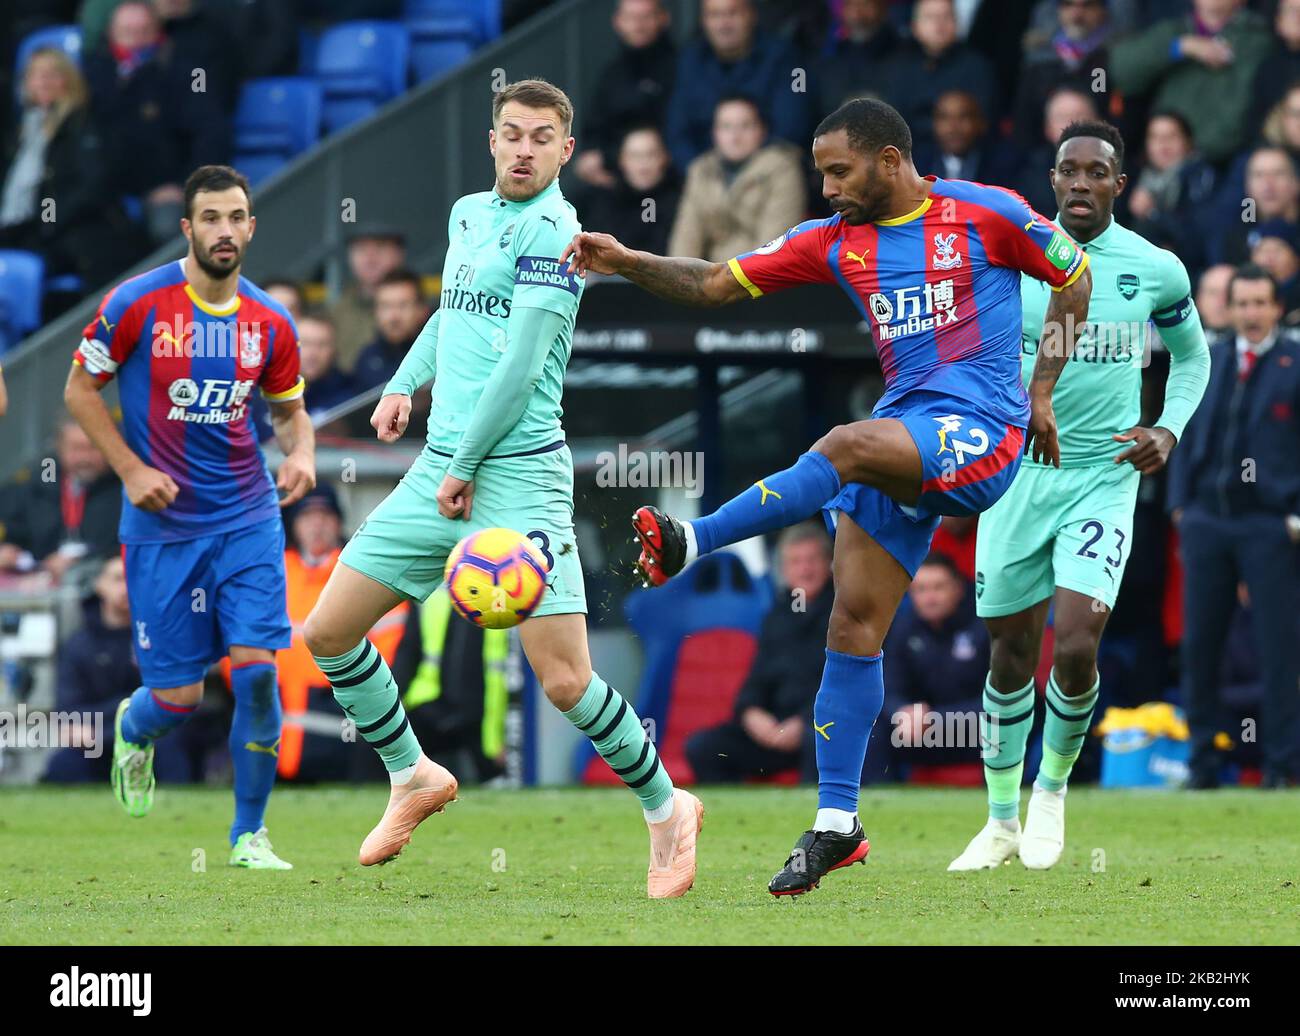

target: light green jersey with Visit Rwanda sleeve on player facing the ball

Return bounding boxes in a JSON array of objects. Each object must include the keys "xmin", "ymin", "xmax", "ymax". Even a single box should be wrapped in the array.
[{"xmin": 428, "ymin": 181, "xmax": 584, "ymax": 456}]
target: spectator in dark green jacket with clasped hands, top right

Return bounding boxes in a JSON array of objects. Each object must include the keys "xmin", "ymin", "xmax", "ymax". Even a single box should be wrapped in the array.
[{"xmin": 1110, "ymin": 0, "xmax": 1271, "ymax": 166}]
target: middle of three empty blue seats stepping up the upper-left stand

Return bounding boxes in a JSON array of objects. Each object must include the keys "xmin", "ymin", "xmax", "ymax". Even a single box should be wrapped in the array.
[{"xmin": 316, "ymin": 21, "xmax": 411, "ymax": 133}]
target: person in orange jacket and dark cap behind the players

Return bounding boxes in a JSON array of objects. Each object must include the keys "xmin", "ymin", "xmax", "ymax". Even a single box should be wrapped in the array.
[{"xmin": 267, "ymin": 481, "xmax": 400, "ymax": 781}]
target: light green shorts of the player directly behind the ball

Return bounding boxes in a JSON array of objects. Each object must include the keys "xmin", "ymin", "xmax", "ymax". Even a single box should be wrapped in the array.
[{"xmin": 339, "ymin": 446, "xmax": 586, "ymax": 616}]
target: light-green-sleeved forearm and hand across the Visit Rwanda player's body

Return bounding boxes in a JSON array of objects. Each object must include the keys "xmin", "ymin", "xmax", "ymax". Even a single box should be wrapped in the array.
[{"xmin": 438, "ymin": 304, "xmax": 566, "ymax": 519}]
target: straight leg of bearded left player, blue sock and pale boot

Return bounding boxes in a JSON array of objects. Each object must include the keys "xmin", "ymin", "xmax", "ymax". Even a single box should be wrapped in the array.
[{"xmin": 230, "ymin": 657, "xmax": 294, "ymax": 871}]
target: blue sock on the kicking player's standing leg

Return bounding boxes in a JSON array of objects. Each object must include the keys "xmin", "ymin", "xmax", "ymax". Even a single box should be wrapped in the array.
[{"xmin": 813, "ymin": 647, "xmax": 885, "ymax": 812}]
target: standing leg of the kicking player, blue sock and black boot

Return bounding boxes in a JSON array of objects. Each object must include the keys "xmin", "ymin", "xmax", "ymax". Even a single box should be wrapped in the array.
[{"xmin": 767, "ymin": 515, "xmax": 911, "ymax": 896}]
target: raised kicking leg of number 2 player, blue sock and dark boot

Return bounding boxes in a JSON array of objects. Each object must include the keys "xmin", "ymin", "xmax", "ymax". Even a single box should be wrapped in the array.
[{"xmin": 632, "ymin": 417, "xmax": 920, "ymax": 586}]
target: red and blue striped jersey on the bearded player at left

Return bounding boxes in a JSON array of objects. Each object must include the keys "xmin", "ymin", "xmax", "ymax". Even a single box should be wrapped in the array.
[{"xmin": 73, "ymin": 260, "xmax": 303, "ymax": 543}]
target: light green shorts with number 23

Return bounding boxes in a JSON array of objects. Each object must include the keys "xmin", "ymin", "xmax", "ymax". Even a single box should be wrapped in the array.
[{"xmin": 975, "ymin": 464, "xmax": 1141, "ymax": 617}]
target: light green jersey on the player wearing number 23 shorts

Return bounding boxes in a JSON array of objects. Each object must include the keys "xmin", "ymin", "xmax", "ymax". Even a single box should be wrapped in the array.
[{"xmin": 1021, "ymin": 216, "xmax": 1195, "ymax": 468}]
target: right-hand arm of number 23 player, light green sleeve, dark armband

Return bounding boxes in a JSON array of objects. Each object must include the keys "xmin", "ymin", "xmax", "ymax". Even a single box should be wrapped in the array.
[{"xmin": 1114, "ymin": 259, "xmax": 1210, "ymax": 474}]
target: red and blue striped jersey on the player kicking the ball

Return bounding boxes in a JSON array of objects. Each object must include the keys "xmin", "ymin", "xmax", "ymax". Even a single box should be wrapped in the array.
[{"xmin": 729, "ymin": 175, "xmax": 1088, "ymax": 428}]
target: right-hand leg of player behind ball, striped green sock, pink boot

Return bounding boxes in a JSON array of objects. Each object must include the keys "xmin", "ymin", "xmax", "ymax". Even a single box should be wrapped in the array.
[{"xmin": 519, "ymin": 614, "xmax": 705, "ymax": 900}]
